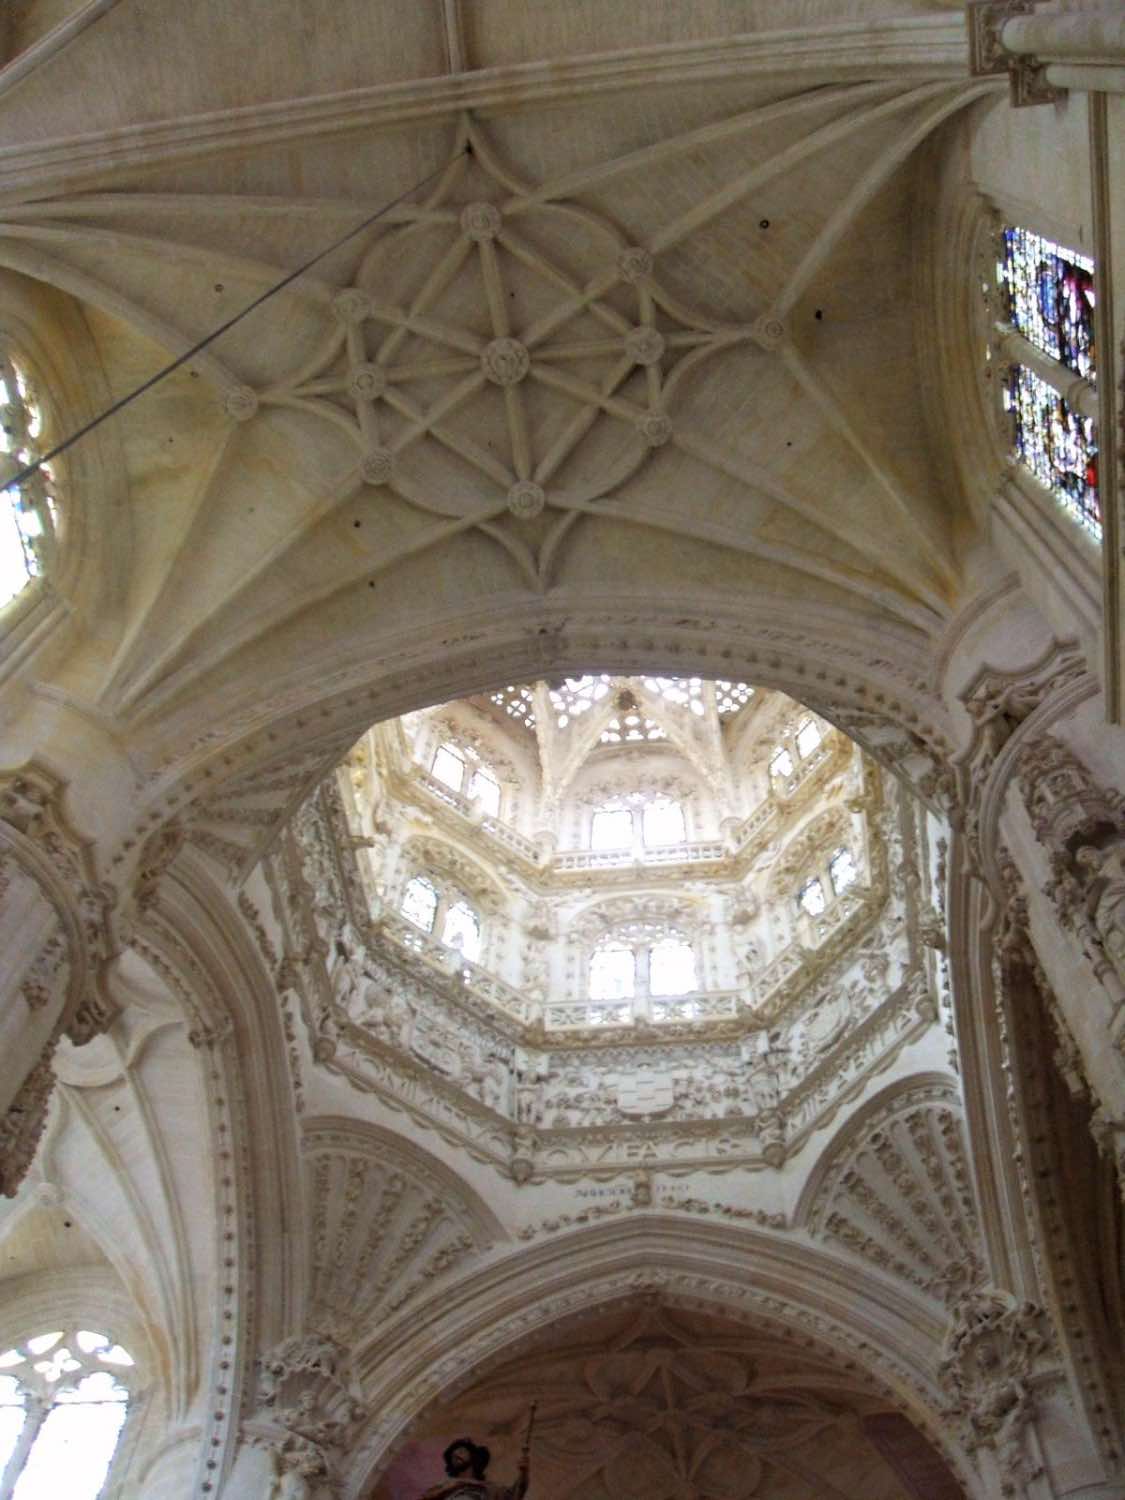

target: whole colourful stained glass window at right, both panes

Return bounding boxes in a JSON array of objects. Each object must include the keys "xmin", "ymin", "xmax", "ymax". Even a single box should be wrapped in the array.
[{"xmin": 998, "ymin": 225, "xmax": 1101, "ymax": 539}]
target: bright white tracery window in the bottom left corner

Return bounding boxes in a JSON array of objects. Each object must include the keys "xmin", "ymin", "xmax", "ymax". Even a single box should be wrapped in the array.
[{"xmin": 0, "ymin": 1329, "xmax": 134, "ymax": 1500}]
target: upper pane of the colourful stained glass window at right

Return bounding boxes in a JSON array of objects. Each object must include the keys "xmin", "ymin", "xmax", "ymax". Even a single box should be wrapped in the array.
[{"xmin": 1001, "ymin": 228, "xmax": 1095, "ymax": 380}]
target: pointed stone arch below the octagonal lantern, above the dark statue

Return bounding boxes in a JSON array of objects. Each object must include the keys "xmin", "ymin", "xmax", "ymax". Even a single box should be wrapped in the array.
[{"xmin": 348, "ymin": 1215, "xmax": 968, "ymax": 1496}]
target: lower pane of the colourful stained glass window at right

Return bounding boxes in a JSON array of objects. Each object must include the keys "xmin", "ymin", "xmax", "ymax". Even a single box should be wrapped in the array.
[{"xmin": 1005, "ymin": 365, "xmax": 1101, "ymax": 539}]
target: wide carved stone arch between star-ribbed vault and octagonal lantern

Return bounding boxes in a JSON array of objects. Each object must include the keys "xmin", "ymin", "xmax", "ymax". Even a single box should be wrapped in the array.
[{"xmin": 143, "ymin": 600, "xmax": 953, "ymax": 876}]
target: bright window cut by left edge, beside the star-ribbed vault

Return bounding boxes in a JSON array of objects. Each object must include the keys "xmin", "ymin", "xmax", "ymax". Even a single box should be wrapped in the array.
[{"xmin": 0, "ymin": 348, "xmax": 57, "ymax": 605}]
